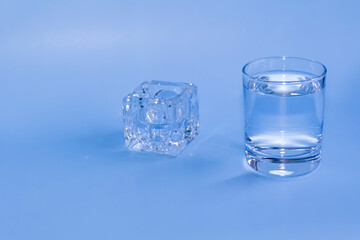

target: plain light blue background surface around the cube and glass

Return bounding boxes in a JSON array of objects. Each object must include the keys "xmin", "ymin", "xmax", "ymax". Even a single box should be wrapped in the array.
[{"xmin": 0, "ymin": 0, "xmax": 360, "ymax": 240}]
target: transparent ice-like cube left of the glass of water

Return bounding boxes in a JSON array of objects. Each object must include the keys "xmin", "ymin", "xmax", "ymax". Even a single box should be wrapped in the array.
[{"xmin": 123, "ymin": 81, "xmax": 199, "ymax": 156}]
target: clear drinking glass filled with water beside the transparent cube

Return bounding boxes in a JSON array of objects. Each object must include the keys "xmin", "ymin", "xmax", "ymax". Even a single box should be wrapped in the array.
[{"xmin": 243, "ymin": 57, "xmax": 327, "ymax": 177}]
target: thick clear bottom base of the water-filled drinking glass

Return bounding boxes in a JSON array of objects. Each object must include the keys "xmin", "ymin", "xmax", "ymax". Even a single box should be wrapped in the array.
[{"xmin": 246, "ymin": 149, "xmax": 321, "ymax": 178}]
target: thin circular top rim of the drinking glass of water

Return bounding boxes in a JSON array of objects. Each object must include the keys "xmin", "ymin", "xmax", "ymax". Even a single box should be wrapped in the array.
[{"xmin": 242, "ymin": 56, "xmax": 327, "ymax": 83}]
